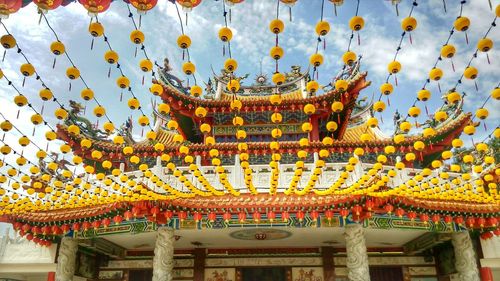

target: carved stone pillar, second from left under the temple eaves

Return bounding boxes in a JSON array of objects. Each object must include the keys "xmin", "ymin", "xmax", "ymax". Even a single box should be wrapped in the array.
[{"xmin": 152, "ymin": 227, "xmax": 174, "ymax": 281}]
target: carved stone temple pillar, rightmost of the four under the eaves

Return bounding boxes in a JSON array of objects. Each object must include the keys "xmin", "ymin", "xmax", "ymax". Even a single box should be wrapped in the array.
[{"xmin": 451, "ymin": 231, "xmax": 480, "ymax": 281}]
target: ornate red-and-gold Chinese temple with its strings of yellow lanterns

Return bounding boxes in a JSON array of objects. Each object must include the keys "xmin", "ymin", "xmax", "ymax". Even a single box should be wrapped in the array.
[{"xmin": 0, "ymin": 0, "xmax": 500, "ymax": 281}]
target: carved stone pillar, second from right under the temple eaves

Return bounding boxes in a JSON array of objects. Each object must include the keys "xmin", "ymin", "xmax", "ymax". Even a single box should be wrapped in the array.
[{"xmin": 344, "ymin": 223, "xmax": 370, "ymax": 281}]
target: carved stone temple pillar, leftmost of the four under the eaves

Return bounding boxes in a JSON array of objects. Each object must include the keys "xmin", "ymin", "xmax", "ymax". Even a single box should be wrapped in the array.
[{"xmin": 56, "ymin": 237, "xmax": 78, "ymax": 281}]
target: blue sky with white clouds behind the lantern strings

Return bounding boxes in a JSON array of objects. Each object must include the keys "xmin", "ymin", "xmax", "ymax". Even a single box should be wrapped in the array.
[{"xmin": 0, "ymin": 0, "xmax": 500, "ymax": 158}]
